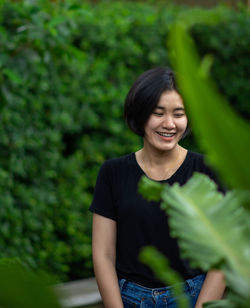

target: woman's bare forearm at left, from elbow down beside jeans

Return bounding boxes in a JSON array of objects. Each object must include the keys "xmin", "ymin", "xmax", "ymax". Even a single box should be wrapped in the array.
[{"xmin": 94, "ymin": 257, "xmax": 123, "ymax": 308}]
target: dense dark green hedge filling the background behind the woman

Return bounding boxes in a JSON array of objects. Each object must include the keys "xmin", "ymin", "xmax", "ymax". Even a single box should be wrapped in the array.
[{"xmin": 0, "ymin": 0, "xmax": 250, "ymax": 281}]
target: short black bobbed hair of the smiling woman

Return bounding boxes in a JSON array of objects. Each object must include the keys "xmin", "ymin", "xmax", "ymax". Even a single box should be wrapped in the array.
[{"xmin": 124, "ymin": 67, "xmax": 189, "ymax": 137}]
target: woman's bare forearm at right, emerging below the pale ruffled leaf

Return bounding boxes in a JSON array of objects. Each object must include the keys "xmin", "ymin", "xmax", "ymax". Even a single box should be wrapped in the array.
[{"xmin": 195, "ymin": 270, "xmax": 226, "ymax": 308}]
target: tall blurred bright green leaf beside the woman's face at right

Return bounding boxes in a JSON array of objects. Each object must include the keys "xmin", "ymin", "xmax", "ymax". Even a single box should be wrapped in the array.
[{"xmin": 170, "ymin": 24, "xmax": 250, "ymax": 189}]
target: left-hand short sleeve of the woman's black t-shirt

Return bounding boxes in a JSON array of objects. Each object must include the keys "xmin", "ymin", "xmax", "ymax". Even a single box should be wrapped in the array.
[{"xmin": 89, "ymin": 162, "xmax": 116, "ymax": 220}]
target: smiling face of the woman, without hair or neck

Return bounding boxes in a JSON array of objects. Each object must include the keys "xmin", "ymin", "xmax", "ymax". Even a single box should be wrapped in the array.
[{"xmin": 144, "ymin": 90, "xmax": 188, "ymax": 151}]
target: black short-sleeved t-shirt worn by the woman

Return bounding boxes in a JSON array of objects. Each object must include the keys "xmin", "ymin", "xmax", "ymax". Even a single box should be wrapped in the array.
[{"xmin": 90, "ymin": 151, "xmax": 224, "ymax": 288}]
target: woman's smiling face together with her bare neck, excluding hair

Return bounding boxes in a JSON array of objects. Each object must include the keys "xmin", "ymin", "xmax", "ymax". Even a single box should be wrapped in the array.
[{"xmin": 136, "ymin": 90, "xmax": 188, "ymax": 181}]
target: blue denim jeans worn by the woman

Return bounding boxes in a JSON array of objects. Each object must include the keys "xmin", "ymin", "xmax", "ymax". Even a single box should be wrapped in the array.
[{"xmin": 119, "ymin": 274, "xmax": 206, "ymax": 308}]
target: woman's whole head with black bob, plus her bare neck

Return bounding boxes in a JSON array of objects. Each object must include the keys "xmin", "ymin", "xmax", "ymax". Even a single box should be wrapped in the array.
[{"xmin": 124, "ymin": 68, "xmax": 189, "ymax": 181}]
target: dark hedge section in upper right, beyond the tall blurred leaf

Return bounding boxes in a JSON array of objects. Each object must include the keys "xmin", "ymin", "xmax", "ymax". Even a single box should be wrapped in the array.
[{"xmin": 191, "ymin": 11, "xmax": 250, "ymax": 120}]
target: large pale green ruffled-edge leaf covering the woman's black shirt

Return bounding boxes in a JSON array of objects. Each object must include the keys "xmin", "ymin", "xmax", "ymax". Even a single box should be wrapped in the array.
[{"xmin": 162, "ymin": 173, "xmax": 250, "ymax": 296}]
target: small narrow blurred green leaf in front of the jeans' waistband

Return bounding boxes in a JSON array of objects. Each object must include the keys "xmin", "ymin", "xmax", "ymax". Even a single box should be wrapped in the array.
[{"xmin": 139, "ymin": 246, "xmax": 190, "ymax": 308}]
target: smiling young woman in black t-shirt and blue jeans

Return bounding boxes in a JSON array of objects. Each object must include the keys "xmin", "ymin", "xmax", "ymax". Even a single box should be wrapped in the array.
[{"xmin": 90, "ymin": 67, "xmax": 225, "ymax": 308}]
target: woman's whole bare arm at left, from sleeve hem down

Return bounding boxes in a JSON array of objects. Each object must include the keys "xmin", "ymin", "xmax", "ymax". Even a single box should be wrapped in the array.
[{"xmin": 92, "ymin": 214, "xmax": 123, "ymax": 308}]
